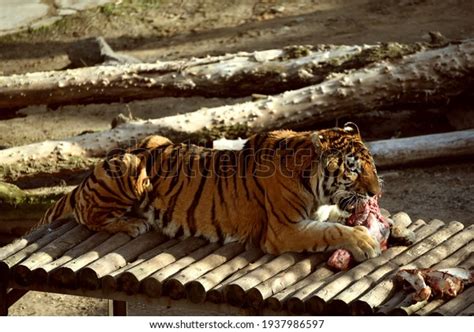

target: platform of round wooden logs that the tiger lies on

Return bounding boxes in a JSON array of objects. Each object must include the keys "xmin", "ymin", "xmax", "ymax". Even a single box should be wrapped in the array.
[{"xmin": 0, "ymin": 215, "xmax": 474, "ymax": 315}]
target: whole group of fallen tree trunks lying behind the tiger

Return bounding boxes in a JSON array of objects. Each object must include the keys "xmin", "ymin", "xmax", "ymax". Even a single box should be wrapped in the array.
[{"xmin": 0, "ymin": 36, "xmax": 474, "ymax": 239}]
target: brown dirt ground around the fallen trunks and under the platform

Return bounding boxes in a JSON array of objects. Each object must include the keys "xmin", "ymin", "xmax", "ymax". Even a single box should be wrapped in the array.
[{"xmin": 0, "ymin": 0, "xmax": 474, "ymax": 315}]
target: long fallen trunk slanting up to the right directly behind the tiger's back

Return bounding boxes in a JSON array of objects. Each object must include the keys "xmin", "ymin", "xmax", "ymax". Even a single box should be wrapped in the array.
[{"xmin": 0, "ymin": 40, "xmax": 474, "ymax": 173}]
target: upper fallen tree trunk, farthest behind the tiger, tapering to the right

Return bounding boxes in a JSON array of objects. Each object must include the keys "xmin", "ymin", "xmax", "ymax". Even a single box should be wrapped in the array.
[{"xmin": 0, "ymin": 43, "xmax": 422, "ymax": 116}]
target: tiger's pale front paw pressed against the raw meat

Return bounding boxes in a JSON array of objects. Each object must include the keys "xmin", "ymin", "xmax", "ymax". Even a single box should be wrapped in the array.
[{"xmin": 346, "ymin": 226, "xmax": 381, "ymax": 262}]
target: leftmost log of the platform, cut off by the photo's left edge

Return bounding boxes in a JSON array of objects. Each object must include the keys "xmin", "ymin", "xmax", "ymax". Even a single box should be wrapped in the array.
[{"xmin": 0, "ymin": 220, "xmax": 77, "ymax": 274}]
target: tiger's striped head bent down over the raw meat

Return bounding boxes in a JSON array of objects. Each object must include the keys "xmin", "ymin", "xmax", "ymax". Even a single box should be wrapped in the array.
[{"xmin": 313, "ymin": 123, "xmax": 381, "ymax": 211}]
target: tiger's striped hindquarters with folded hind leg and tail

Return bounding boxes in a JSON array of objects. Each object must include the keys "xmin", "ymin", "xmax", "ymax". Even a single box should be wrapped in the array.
[{"xmin": 36, "ymin": 153, "xmax": 154, "ymax": 237}]
